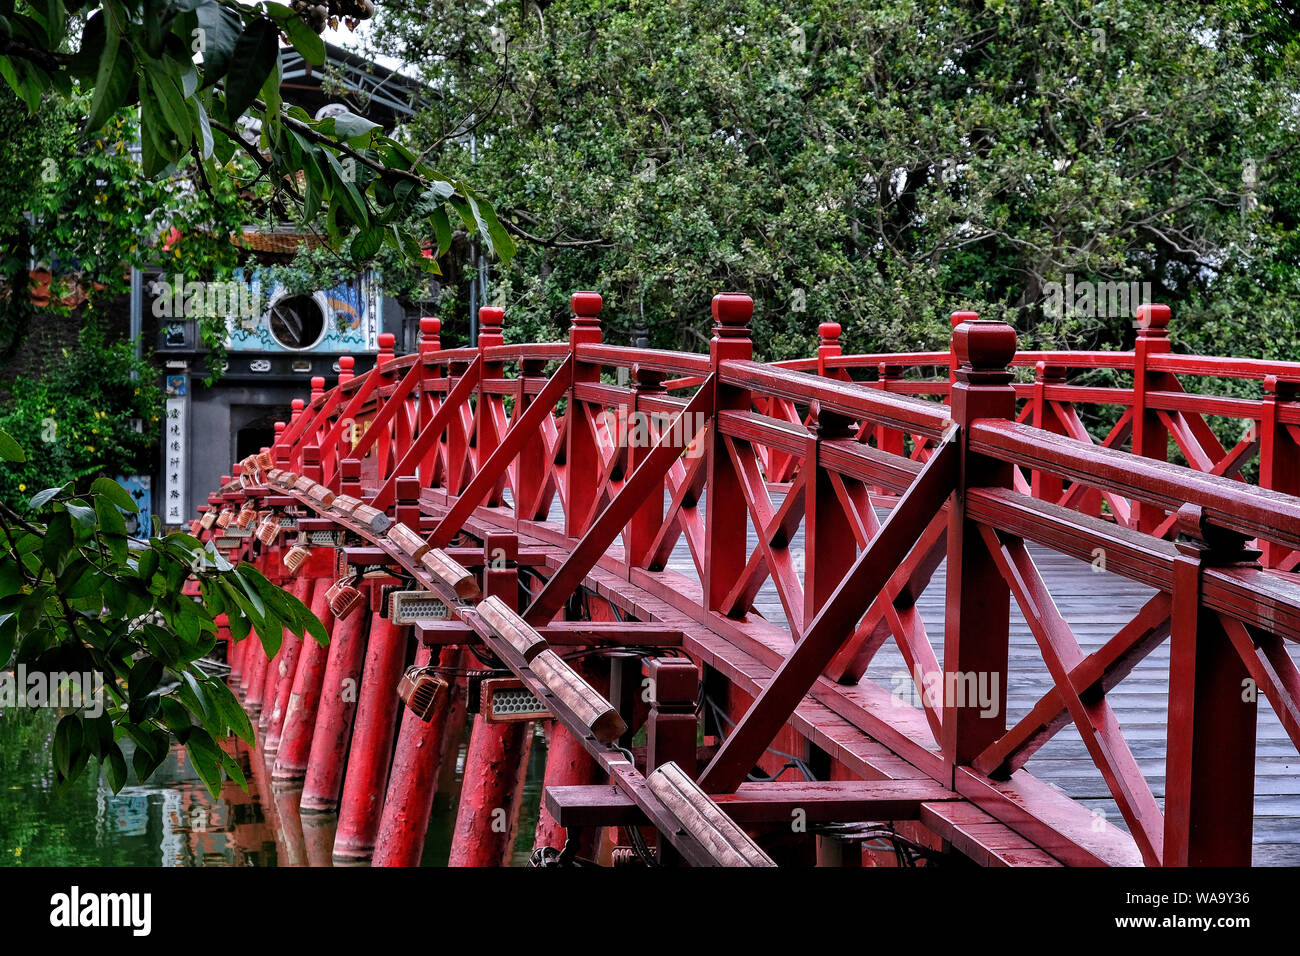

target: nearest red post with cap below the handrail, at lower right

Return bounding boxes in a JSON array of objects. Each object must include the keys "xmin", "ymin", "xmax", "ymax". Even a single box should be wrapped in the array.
[{"xmin": 1164, "ymin": 505, "xmax": 1258, "ymax": 866}]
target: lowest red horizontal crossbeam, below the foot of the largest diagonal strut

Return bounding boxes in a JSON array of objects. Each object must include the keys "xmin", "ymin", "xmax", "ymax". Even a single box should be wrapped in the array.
[{"xmin": 545, "ymin": 779, "xmax": 959, "ymax": 827}]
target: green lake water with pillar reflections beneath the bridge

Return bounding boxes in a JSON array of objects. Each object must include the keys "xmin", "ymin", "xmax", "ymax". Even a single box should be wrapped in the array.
[{"xmin": 0, "ymin": 710, "xmax": 546, "ymax": 866}]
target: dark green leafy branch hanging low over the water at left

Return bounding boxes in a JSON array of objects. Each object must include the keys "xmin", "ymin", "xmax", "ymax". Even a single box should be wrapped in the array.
[{"xmin": 0, "ymin": 432, "xmax": 328, "ymax": 792}]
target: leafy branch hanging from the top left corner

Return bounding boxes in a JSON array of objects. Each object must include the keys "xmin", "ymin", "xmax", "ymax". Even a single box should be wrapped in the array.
[{"xmin": 0, "ymin": 0, "xmax": 515, "ymax": 277}]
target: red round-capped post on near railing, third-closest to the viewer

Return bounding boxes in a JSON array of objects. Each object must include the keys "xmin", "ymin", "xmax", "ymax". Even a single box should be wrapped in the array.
[{"xmin": 564, "ymin": 293, "xmax": 602, "ymax": 537}]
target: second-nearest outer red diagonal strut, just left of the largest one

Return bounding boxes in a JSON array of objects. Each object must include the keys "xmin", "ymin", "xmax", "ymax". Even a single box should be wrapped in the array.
[{"xmin": 524, "ymin": 376, "xmax": 714, "ymax": 627}]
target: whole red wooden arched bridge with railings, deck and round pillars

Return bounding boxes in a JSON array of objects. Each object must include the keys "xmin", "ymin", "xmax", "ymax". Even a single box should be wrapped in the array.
[{"xmin": 194, "ymin": 293, "xmax": 1300, "ymax": 866}]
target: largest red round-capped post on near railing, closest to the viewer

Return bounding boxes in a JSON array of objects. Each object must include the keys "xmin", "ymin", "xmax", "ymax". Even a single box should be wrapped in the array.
[{"xmin": 941, "ymin": 312, "xmax": 1015, "ymax": 769}]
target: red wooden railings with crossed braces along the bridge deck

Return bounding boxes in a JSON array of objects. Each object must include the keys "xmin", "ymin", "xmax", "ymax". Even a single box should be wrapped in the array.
[{"xmin": 213, "ymin": 293, "xmax": 1300, "ymax": 865}]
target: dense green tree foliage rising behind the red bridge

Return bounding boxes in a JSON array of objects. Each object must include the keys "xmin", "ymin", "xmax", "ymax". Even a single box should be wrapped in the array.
[{"xmin": 376, "ymin": 0, "xmax": 1300, "ymax": 359}]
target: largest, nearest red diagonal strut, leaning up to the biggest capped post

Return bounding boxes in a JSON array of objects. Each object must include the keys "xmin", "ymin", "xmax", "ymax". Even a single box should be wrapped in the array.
[{"xmin": 699, "ymin": 427, "xmax": 959, "ymax": 793}]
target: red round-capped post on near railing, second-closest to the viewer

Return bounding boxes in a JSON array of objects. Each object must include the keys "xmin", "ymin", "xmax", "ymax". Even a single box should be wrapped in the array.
[{"xmin": 702, "ymin": 293, "xmax": 754, "ymax": 611}]
